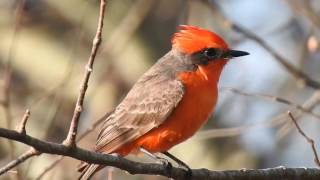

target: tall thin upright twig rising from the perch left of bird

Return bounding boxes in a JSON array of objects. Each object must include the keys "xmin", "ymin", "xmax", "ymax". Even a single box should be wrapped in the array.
[{"xmin": 63, "ymin": 0, "xmax": 106, "ymax": 147}]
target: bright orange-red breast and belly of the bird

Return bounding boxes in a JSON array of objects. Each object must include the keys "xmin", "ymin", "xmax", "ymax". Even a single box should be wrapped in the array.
[{"xmin": 116, "ymin": 67, "xmax": 217, "ymax": 156}]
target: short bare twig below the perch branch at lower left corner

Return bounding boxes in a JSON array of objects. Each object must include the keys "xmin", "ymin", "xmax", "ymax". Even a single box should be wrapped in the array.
[{"xmin": 0, "ymin": 147, "xmax": 40, "ymax": 175}]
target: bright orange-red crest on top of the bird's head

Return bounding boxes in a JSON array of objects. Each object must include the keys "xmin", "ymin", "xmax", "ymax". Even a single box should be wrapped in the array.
[{"xmin": 171, "ymin": 25, "xmax": 228, "ymax": 54}]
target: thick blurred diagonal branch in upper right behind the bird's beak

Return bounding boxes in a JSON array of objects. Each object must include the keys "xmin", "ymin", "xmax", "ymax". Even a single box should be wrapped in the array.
[{"xmin": 202, "ymin": 0, "xmax": 320, "ymax": 89}]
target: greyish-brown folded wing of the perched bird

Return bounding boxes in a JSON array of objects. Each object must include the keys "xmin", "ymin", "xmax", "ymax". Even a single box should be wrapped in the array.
[{"xmin": 96, "ymin": 52, "xmax": 184, "ymax": 153}]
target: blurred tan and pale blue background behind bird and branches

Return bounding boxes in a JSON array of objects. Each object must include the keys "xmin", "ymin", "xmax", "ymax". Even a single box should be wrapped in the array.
[{"xmin": 0, "ymin": 0, "xmax": 320, "ymax": 179}]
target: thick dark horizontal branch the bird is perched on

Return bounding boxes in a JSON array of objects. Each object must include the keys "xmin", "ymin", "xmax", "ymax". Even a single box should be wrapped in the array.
[{"xmin": 0, "ymin": 128, "xmax": 320, "ymax": 180}]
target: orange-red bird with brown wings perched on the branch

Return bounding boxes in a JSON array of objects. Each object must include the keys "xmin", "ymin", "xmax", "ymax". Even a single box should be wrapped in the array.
[{"xmin": 79, "ymin": 25, "xmax": 249, "ymax": 179}]
